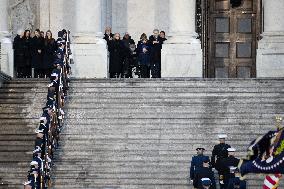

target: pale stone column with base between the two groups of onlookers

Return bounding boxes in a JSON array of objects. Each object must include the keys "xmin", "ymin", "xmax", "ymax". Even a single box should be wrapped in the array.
[{"xmin": 72, "ymin": 0, "xmax": 108, "ymax": 78}]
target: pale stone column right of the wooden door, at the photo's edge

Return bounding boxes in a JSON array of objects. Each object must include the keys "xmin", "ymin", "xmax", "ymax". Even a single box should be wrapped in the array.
[{"xmin": 256, "ymin": 0, "xmax": 284, "ymax": 78}]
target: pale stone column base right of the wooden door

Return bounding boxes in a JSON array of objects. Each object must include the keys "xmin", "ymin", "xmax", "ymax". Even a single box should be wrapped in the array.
[{"xmin": 256, "ymin": 32, "xmax": 284, "ymax": 78}]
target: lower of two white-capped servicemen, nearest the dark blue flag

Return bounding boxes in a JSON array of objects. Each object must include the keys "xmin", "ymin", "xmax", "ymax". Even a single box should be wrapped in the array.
[{"xmin": 220, "ymin": 148, "xmax": 240, "ymax": 188}]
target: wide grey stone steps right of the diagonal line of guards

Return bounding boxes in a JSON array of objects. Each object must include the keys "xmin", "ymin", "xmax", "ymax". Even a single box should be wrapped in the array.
[{"xmin": 49, "ymin": 79, "xmax": 284, "ymax": 189}]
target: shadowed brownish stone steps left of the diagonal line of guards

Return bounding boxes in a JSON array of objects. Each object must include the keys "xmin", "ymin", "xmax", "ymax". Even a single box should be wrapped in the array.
[{"xmin": 0, "ymin": 79, "xmax": 47, "ymax": 189}]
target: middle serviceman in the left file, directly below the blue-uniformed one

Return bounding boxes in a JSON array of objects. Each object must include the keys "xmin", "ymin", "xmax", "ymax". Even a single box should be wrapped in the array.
[{"xmin": 193, "ymin": 157, "xmax": 216, "ymax": 189}]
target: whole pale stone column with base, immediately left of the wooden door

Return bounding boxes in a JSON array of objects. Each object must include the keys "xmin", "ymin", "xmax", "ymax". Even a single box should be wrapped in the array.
[{"xmin": 162, "ymin": 0, "xmax": 202, "ymax": 77}]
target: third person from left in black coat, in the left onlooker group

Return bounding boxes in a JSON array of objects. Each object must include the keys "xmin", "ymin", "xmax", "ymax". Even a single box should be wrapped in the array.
[{"xmin": 31, "ymin": 29, "xmax": 45, "ymax": 78}]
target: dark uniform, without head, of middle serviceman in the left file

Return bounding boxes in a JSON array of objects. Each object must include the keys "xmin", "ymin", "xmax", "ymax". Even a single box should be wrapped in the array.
[{"xmin": 193, "ymin": 167, "xmax": 216, "ymax": 189}]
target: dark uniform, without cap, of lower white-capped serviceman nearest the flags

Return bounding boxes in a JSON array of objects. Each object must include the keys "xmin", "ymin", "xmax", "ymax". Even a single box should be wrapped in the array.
[{"xmin": 220, "ymin": 156, "xmax": 240, "ymax": 188}]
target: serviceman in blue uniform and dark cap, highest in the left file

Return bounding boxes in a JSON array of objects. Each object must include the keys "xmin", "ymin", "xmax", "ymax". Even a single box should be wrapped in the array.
[{"xmin": 190, "ymin": 148, "xmax": 209, "ymax": 182}]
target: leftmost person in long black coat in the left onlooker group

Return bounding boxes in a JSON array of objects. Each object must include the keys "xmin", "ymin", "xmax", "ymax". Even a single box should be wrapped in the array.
[{"xmin": 13, "ymin": 30, "xmax": 26, "ymax": 78}]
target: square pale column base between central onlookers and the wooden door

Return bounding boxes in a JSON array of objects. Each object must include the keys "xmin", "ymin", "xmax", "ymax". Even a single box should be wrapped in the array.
[{"xmin": 161, "ymin": 43, "xmax": 203, "ymax": 78}]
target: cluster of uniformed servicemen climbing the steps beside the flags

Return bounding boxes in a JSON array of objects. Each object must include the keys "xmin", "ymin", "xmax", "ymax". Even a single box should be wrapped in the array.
[{"xmin": 190, "ymin": 135, "xmax": 246, "ymax": 189}]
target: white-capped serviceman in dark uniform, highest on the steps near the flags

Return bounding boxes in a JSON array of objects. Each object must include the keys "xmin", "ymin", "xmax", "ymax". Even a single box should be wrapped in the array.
[{"xmin": 211, "ymin": 134, "xmax": 231, "ymax": 189}]
